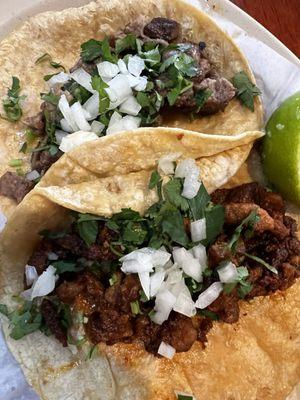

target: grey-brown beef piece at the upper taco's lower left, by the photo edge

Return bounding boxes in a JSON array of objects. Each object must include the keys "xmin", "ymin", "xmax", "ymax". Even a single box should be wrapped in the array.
[{"xmin": 0, "ymin": 171, "xmax": 34, "ymax": 203}]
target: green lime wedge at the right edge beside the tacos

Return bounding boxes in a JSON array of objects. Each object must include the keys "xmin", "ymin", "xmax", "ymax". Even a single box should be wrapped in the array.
[{"xmin": 262, "ymin": 92, "xmax": 300, "ymax": 204}]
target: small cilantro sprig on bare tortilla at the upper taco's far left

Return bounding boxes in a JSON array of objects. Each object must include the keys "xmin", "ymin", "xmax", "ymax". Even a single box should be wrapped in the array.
[{"xmin": 2, "ymin": 76, "xmax": 25, "ymax": 122}]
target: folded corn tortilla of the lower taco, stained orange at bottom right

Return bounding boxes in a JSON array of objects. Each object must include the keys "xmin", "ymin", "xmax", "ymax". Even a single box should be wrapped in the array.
[{"xmin": 0, "ymin": 132, "xmax": 300, "ymax": 400}]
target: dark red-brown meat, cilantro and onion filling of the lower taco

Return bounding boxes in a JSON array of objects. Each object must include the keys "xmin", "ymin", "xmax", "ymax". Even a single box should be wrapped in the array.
[{"xmin": 0, "ymin": 166, "xmax": 300, "ymax": 358}]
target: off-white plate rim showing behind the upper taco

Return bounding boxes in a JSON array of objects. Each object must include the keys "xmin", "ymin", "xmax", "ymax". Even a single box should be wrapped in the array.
[{"xmin": 0, "ymin": 0, "xmax": 300, "ymax": 66}]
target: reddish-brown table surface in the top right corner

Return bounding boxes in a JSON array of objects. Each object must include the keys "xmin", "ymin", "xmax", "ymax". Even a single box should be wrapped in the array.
[{"xmin": 232, "ymin": 0, "xmax": 300, "ymax": 57}]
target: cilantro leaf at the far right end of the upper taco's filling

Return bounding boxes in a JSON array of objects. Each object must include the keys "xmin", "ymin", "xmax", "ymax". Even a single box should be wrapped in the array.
[{"xmin": 232, "ymin": 71, "xmax": 261, "ymax": 111}]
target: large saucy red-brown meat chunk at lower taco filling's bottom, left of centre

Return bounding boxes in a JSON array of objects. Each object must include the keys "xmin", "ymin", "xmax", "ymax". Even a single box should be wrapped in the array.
[{"xmin": 86, "ymin": 305, "xmax": 133, "ymax": 344}]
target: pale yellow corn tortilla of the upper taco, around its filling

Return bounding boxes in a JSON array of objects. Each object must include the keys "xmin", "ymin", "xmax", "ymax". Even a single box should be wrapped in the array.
[{"xmin": 0, "ymin": 0, "xmax": 262, "ymax": 215}]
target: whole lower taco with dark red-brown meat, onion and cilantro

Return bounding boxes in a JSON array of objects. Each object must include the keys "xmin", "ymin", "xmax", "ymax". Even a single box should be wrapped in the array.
[{"xmin": 0, "ymin": 132, "xmax": 300, "ymax": 400}]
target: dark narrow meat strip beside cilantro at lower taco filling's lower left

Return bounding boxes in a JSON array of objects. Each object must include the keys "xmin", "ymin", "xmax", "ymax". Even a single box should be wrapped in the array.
[{"xmin": 41, "ymin": 299, "xmax": 68, "ymax": 347}]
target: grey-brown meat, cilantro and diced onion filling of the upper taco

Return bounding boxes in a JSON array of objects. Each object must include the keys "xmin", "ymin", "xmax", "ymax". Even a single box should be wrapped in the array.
[{"xmin": 3, "ymin": 16, "xmax": 260, "ymax": 203}]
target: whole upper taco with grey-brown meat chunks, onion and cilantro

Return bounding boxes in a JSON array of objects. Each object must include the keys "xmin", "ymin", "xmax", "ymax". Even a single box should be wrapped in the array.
[{"xmin": 0, "ymin": 0, "xmax": 262, "ymax": 216}]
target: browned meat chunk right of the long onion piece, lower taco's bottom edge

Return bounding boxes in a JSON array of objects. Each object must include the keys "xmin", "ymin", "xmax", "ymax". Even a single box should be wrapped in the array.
[{"xmin": 208, "ymin": 290, "xmax": 240, "ymax": 324}]
